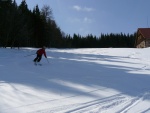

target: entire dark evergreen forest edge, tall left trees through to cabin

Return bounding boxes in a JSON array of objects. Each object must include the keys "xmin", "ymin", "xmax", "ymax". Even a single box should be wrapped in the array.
[{"xmin": 0, "ymin": 0, "xmax": 136, "ymax": 48}]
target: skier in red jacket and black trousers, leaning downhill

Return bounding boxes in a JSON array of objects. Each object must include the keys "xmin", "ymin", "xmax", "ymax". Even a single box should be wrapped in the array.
[{"xmin": 33, "ymin": 46, "xmax": 47, "ymax": 63}]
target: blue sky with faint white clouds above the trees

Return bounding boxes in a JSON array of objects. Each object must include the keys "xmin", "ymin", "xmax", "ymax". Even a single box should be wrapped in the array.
[{"xmin": 16, "ymin": 0, "xmax": 150, "ymax": 36}]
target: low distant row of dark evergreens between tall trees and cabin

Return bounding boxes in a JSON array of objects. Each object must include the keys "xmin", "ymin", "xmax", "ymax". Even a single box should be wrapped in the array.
[{"xmin": 64, "ymin": 33, "xmax": 136, "ymax": 48}]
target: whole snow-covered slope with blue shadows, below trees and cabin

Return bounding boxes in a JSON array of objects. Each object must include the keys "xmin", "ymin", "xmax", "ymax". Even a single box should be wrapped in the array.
[{"xmin": 0, "ymin": 48, "xmax": 150, "ymax": 113}]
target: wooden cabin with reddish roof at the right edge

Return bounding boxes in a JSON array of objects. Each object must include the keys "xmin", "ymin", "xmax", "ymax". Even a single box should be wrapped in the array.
[{"xmin": 135, "ymin": 28, "xmax": 150, "ymax": 48}]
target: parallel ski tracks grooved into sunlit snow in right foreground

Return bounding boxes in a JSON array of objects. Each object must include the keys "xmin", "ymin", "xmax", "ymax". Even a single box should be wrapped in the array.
[{"xmin": 26, "ymin": 94, "xmax": 150, "ymax": 113}]
